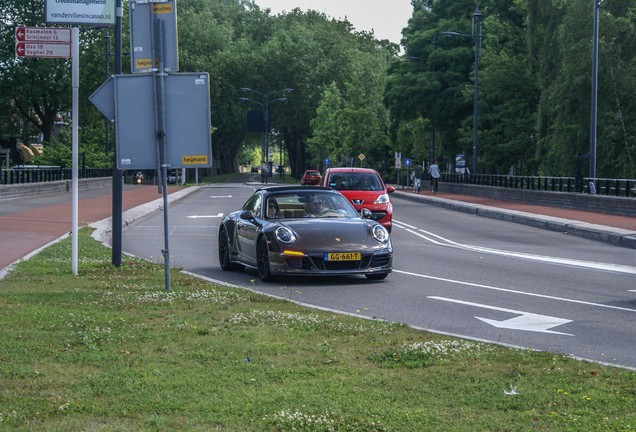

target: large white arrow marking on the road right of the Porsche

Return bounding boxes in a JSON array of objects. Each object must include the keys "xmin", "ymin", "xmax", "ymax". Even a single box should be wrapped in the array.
[{"xmin": 428, "ymin": 296, "xmax": 574, "ymax": 336}]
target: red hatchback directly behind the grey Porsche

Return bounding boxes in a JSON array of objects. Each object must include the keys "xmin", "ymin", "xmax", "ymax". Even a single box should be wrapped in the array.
[{"xmin": 321, "ymin": 168, "xmax": 395, "ymax": 232}]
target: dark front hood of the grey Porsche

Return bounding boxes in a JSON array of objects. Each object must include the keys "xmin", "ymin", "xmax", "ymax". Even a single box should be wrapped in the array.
[{"xmin": 281, "ymin": 218, "xmax": 385, "ymax": 250}]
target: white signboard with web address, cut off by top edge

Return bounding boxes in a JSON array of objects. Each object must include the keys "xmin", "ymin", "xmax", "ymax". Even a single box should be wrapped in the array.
[{"xmin": 44, "ymin": 0, "xmax": 116, "ymax": 26}]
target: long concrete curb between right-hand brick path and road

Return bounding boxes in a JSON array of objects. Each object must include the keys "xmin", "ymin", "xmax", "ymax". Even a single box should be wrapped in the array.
[{"xmin": 391, "ymin": 190, "xmax": 636, "ymax": 249}]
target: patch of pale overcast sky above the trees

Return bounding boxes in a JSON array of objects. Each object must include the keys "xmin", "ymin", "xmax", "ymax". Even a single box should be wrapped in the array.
[{"xmin": 255, "ymin": 0, "xmax": 413, "ymax": 44}]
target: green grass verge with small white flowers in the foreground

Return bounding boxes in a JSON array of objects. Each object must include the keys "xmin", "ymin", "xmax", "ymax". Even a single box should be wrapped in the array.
[{"xmin": 0, "ymin": 229, "xmax": 636, "ymax": 431}]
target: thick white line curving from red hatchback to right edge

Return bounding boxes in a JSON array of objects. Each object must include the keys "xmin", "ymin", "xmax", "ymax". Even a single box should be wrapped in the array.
[{"xmin": 394, "ymin": 221, "xmax": 636, "ymax": 274}]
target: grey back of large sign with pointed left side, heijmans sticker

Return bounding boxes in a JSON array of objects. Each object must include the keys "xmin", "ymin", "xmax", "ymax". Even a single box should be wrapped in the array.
[{"xmin": 89, "ymin": 72, "xmax": 212, "ymax": 170}]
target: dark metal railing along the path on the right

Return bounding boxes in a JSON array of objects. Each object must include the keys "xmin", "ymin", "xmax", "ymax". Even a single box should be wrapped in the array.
[{"xmin": 442, "ymin": 173, "xmax": 636, "ymax": 198}]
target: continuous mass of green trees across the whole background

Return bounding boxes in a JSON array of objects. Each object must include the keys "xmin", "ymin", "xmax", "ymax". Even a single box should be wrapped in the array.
[{"xmin": 0, "ymin": 0, "xmax": 636, "ymax": 177}]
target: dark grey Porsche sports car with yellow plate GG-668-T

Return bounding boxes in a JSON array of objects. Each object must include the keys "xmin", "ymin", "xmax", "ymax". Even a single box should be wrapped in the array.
[{"xmin": 218, "ymin": 186, "xmax": 393, "ymax": 281}]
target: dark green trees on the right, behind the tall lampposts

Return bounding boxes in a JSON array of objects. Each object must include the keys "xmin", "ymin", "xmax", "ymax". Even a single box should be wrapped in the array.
[{"xmin": 385, "ymin": 0, "xmax": 636, "ymax": 177}]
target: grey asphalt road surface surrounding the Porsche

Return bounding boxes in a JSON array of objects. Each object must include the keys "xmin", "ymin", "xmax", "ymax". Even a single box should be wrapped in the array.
[{"xmin": 123, "ymin": 184, "xmax": 636, "ymax": 369}]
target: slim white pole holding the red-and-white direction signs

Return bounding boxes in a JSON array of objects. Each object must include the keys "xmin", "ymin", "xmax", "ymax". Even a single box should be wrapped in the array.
[{"xmin": 71, "ymin": 27, "xmax": 79, "ymax": 276}]
